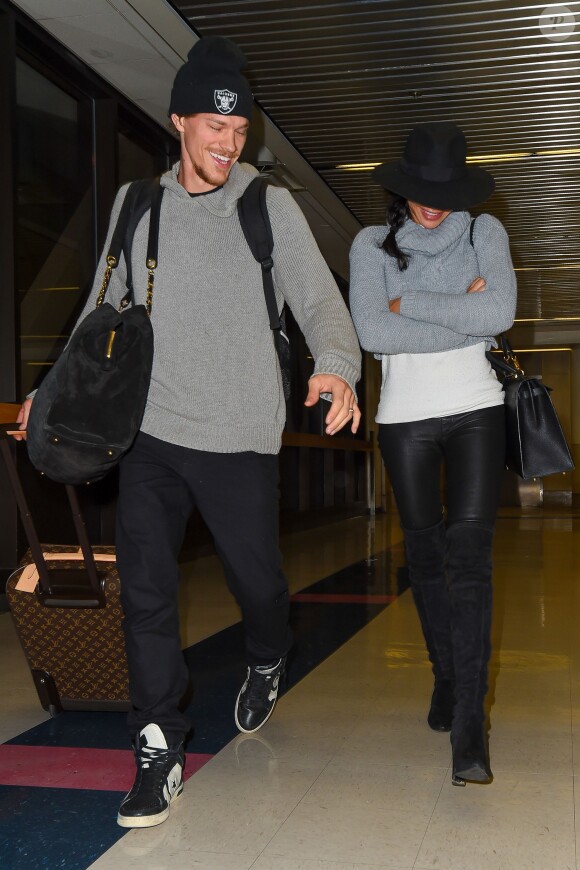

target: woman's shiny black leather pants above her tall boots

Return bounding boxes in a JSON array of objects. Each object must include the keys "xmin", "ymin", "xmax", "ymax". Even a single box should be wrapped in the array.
[{"xmin": 379, "ymin": 405, "xmax": 505, "ymax": 530}]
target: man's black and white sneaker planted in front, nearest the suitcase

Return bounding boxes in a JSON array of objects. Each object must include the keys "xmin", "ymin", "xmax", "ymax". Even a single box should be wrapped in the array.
[{"xmin": 117, "ymin": 723, "xmax": 185, "ymax": 828}]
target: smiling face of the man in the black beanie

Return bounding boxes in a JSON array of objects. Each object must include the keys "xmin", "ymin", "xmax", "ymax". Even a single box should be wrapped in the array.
[{"xmin": 171, "ymin": 114, "xmax": 250, "ymax": 193}]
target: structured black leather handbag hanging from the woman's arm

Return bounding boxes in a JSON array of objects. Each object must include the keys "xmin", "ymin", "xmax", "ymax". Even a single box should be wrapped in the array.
[{"xmin": 487, "ymin": 336, "xmax": 574, "ymax": 480}]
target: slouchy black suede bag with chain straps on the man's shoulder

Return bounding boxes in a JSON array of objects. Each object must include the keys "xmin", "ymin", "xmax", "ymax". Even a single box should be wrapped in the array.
[{"xmin": 27, "ymin": 181, "xmax": 164, "ymax": 484}]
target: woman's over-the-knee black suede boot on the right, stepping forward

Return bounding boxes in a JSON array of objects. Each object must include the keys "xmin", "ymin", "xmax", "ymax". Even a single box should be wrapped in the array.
[{"xmin": 447, "ymin": 523, "xmax": 493, "ymax": 785}]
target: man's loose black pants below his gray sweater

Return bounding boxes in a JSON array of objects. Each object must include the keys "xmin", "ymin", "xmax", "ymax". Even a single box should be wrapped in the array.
[{"xmin": 117, "ymin": 433, "xmax": 291, "ymax": 735}]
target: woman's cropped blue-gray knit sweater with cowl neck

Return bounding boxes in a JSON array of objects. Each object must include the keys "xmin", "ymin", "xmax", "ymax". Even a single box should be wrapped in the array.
[{"xmin": 350, "ymin": 211, "xmax": 516, "ymax": 356}]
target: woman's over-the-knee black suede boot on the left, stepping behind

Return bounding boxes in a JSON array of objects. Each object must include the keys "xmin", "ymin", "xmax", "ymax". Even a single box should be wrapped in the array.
[{"xmin": 404, "ymin": 521, "xmax": 454, "ymax": 731}]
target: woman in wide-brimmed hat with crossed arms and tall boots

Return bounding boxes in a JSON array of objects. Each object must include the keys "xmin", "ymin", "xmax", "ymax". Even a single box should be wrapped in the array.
[{"xmin": 351, "ymin": 122, "xmax": 516, "ymax": 785}]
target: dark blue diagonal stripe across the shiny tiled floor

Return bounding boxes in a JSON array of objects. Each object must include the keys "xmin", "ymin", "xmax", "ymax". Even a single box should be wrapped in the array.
[{"xmin": 0, "ymin": 547, "xmax": 408, "ymax": 870}]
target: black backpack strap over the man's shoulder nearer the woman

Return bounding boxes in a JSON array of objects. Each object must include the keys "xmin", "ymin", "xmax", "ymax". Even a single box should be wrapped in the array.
[{"xmin": 238, "ymin": 176, "xmax": 283, "ymax": 330}]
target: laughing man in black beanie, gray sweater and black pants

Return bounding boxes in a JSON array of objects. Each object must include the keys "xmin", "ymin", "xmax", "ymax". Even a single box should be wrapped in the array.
[{"xmin": 15, "ymin": 37, "xmax": 360, "ymax": 827}]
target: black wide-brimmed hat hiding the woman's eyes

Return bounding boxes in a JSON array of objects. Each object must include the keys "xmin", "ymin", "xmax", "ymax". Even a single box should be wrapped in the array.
[{"xmin": 372, "ymin": 121, "xmax": 495, "ymax": 211}]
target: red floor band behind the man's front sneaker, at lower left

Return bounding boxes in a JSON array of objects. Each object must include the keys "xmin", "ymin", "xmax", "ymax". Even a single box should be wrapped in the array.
[{"xmin": 0, "ymin": 744, "xmax": 213, "ymax": 792}]
